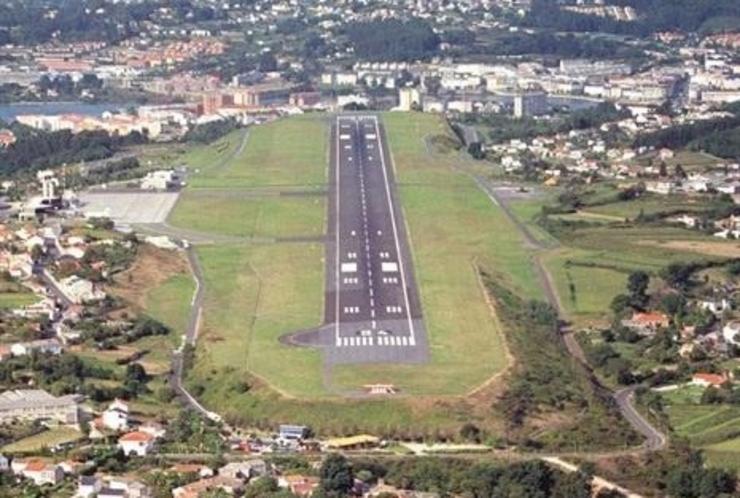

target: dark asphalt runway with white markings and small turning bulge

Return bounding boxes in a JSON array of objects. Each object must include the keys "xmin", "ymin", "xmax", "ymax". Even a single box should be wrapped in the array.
[{"xmin": 288, "ymin": 116, "xmax": 428, "ymax": 364}]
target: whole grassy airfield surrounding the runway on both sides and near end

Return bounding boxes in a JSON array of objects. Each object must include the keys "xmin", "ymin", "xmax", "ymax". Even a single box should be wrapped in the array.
[{"xmin": 169, "ymin": 114, "xmax": 542, "ymax": 433}]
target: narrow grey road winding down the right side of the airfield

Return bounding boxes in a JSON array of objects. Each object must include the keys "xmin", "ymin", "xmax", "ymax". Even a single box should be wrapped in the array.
[{"xmin": 475, "ymin": 176, "xmax": 668, "ymax": 451}]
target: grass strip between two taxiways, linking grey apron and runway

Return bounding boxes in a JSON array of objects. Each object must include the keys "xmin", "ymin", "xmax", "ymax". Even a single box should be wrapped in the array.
[{"xmin": 170, "ymin": 190, "xmax": 326, "ymax": 237}]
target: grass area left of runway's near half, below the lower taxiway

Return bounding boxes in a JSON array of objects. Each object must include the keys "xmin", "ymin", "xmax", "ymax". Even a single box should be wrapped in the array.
[{"xmin": 192, "ymin": 244, "xmax": 324, "ymax": 399}]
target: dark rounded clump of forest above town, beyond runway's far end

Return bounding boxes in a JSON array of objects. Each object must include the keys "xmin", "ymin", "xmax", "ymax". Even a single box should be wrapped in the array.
[{"xmin": 347, "ymin": 19, "xmax": 440, "ymax": 61}]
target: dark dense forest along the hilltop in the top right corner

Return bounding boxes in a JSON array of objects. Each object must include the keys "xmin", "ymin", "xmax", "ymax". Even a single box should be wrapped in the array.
[{"xmin": 523, "ymin": 0, "xmax": 740, "ymax": 36}]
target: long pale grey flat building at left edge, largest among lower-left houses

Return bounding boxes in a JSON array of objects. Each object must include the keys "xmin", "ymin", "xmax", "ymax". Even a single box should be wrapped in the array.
[{"xmin": 0, "ymin": 389, "xmax": 82, "ymax": 424}]
